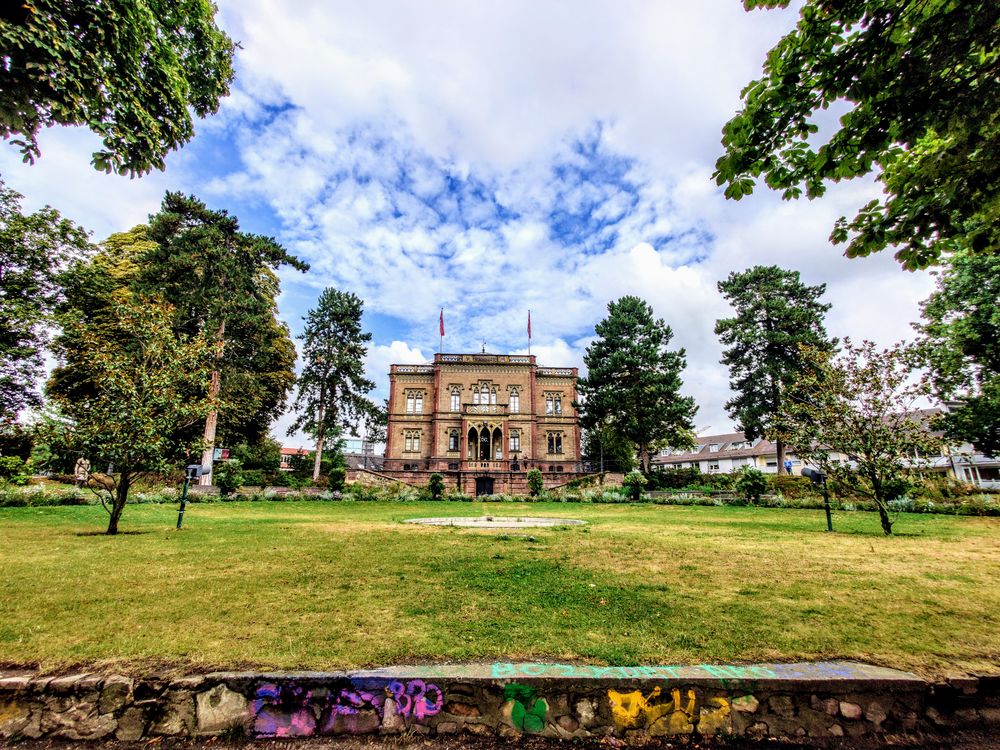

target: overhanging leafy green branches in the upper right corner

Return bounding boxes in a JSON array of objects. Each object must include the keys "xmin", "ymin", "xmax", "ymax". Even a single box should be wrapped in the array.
[{"xmin": 714, "ymin": 0, "xmax": 1000, "ymax": 269}]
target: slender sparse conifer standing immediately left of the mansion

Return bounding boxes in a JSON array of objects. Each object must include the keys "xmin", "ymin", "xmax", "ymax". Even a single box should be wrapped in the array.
[{"xmin": 288, "ymin": 289, "xmax": 378, "ymax": 480}]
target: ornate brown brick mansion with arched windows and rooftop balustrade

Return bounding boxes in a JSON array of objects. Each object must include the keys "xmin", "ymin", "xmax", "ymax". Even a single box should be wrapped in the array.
[{"xmin": 382, "ymin": 353, "xmax": 583, "ymax": 495}]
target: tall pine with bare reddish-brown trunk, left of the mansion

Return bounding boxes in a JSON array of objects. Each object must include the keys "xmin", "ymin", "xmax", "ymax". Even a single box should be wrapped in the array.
[{"xmin": 136, "ymin": 192, "xmax": 309, "ymax": 484}]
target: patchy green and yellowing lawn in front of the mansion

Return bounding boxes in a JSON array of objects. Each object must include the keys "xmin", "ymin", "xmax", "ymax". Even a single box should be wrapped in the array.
[{"xmin": 0, "ymin": 502, "xmax": 1000, "ymax": 675}]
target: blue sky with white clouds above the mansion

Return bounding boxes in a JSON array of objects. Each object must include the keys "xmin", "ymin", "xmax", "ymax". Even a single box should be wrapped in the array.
[{"xmin": 0, "ymin": 0, "xmax": 933, "ymax": 444}]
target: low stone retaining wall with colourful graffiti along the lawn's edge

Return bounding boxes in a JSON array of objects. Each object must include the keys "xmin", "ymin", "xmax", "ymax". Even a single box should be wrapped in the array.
[{"xmin": 0, "ymin": 662, "xmax": 1000, "ymax": 741}]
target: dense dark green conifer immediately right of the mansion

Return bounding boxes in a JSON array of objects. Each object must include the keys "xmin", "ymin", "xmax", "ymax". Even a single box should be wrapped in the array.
[{"xmin": 578, "ymin": 296, "xmax": 698, "ymax": 474}]
